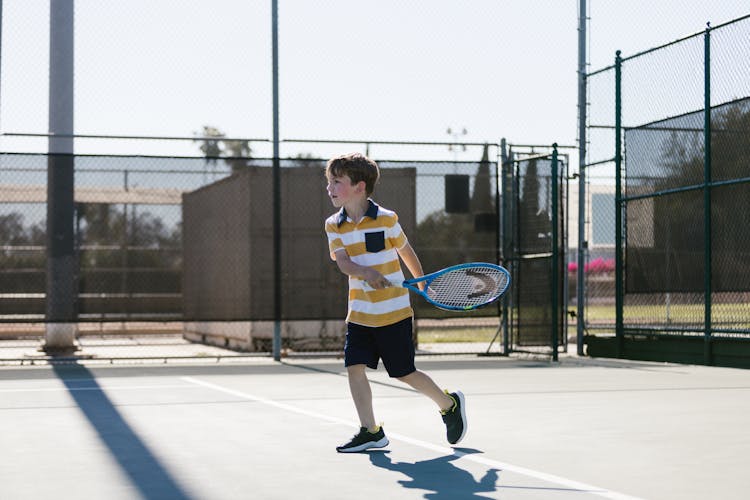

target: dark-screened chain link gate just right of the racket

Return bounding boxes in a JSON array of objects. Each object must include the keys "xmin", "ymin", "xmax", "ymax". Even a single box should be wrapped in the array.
[{"xmin": 502, "ymin": 146, "xmax": 568, "ymax": 360}]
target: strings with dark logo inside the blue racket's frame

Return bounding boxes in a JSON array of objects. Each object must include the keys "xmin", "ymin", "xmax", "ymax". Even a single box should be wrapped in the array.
[{"xmin": 427, "ymin": 266, "xmax": 508, "ymax": 307}]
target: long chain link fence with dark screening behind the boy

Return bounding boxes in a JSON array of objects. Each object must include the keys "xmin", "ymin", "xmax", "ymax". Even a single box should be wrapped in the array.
[{"xmin": 0, "ymin": 145, "xmax": 506, "ymax": 357}]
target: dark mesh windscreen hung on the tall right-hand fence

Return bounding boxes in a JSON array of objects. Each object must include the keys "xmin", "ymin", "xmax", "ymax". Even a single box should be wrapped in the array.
[{"xmin": 640, "ymin": 99, "xmax": 750, "ymax": 292}]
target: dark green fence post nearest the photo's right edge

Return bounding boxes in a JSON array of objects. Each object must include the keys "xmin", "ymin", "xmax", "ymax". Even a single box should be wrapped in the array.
[{"xmin": 703, "ymin": 24, "xmax": 712, "ymax": 365}]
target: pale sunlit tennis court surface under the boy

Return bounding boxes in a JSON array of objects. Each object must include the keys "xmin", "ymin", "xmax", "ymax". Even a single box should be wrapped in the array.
[{"xmin": 0, "ymin": 356, "xmax": 750, "ymax": 500}]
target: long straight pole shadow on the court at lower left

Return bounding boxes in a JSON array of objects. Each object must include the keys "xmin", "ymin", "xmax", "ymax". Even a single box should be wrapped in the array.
[{"xmin": 52, "ymin": 365, "xmax": 191, "ymax": 500}]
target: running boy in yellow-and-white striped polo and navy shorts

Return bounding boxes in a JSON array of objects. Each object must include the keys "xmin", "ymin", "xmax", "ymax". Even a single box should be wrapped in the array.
[{"xmin": 325, "ymin": 153, "xmax": 466, "ymax": 453}]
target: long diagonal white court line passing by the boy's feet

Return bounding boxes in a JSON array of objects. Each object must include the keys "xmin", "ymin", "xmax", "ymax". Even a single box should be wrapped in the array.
[{"xmin": 180, "ymin": 377, "xmax": 639, "ymax": 500}]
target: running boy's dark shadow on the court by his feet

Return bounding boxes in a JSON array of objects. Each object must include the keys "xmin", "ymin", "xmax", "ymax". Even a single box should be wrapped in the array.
[{"xmin": 369, "ymin": 449, "xmax": 499, "ymax": 500}]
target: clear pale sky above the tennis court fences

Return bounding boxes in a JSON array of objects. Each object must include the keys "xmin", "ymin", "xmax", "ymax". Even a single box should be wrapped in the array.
[{"xmin": 0, "ymin": 0, "xmax": 750, "ymax": 160}]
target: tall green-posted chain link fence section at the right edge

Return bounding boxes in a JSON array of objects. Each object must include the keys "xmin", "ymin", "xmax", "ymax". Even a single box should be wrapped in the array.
[{"xmin": 586, "ymin": 16, "xmax": 750, "ymax": 364}]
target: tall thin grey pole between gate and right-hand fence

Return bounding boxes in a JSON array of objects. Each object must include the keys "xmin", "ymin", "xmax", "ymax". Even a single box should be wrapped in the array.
[{"xmin": 576, "ymin": 0, "xmax": 588, "ymax": 356}]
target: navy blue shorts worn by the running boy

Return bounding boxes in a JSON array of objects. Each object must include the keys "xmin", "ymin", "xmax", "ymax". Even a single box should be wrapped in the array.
[{"xmin": 344, "ymin": 318, "xmax": 416, "ymax": 378}]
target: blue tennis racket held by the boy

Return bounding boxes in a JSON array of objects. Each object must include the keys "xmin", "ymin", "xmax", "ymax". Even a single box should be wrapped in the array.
[{"xmin": 401, "ymin": 262, "xmax": 510, "ymax": 311}]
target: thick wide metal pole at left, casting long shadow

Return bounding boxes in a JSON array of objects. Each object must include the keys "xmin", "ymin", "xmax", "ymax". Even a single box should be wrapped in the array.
[{"xmin": 44, "ymin": 0, "xmax": 78, "ymax": 354}]
